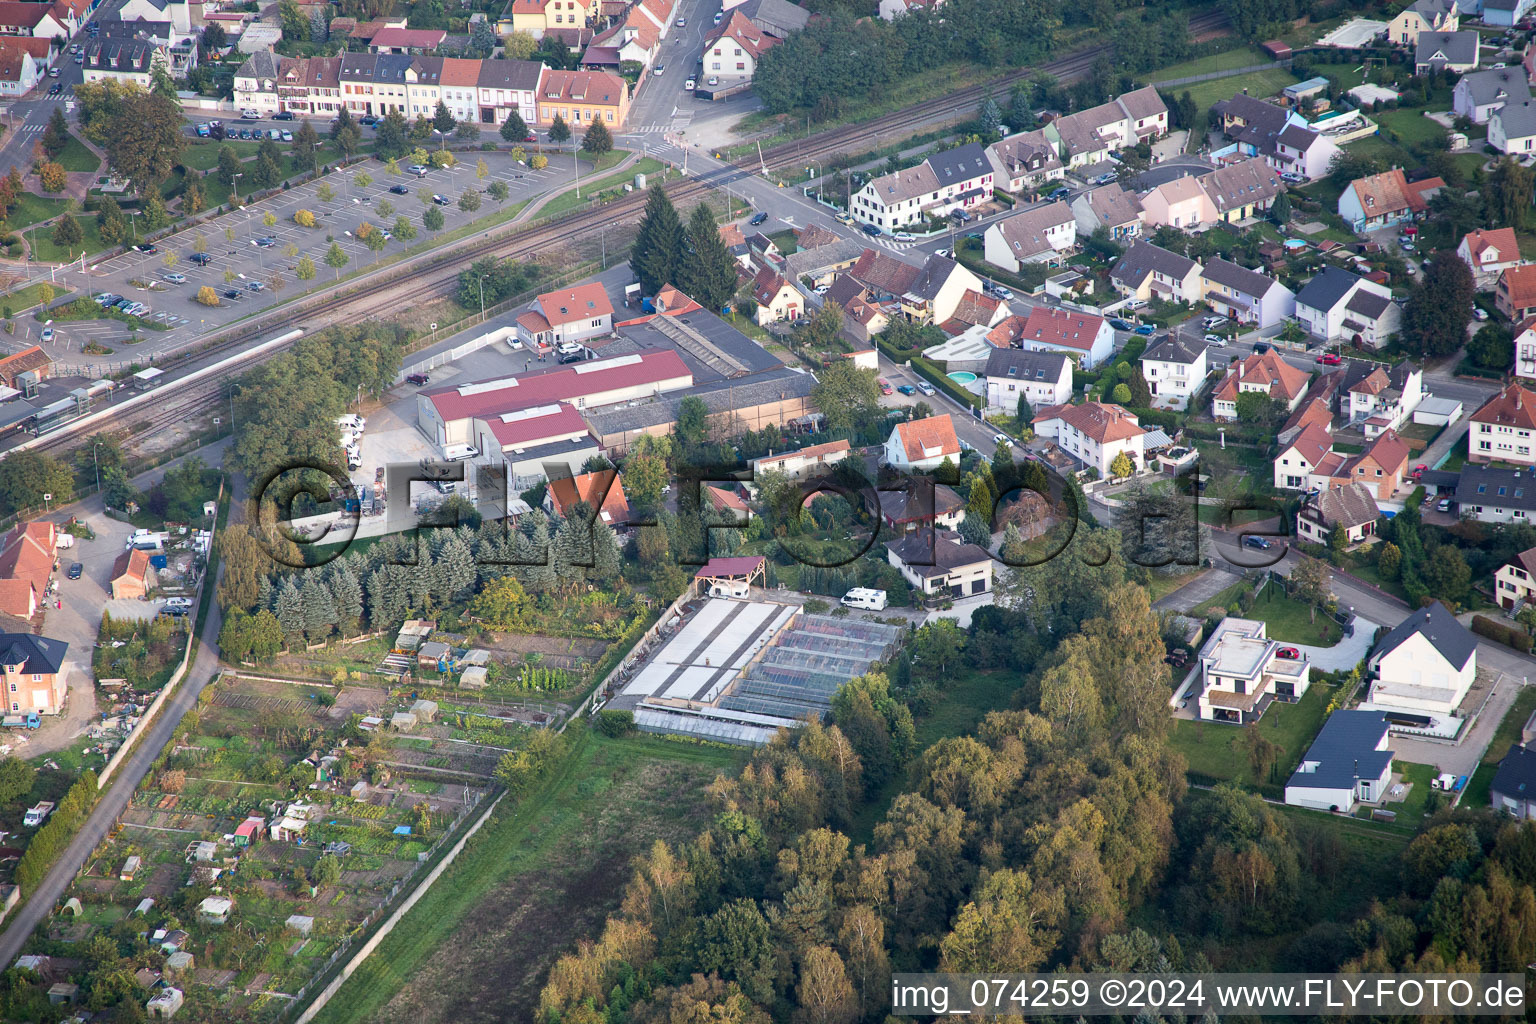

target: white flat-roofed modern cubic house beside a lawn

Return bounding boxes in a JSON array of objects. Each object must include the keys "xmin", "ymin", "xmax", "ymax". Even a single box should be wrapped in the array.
[{"xmin": 1197, "ymin": 616, "xmax": 1312, "ymax": 725}]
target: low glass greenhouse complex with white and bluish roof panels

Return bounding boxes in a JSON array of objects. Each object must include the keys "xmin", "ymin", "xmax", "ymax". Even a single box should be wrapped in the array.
[{"xmin": 611, "ymin": 597, "xmax": 902, "ymax": 743}]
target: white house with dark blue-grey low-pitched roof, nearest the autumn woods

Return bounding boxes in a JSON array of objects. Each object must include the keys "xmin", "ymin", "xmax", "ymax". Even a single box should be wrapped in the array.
[{"xmin": 1286, "ymin": 709, "xmax": 1396, "ymax": 814}]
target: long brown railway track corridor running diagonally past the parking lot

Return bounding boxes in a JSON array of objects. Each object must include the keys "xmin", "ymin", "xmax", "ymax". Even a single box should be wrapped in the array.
[{"xmin": 27, "ymin": 11, "xmax": 1226, "ymax": 457}]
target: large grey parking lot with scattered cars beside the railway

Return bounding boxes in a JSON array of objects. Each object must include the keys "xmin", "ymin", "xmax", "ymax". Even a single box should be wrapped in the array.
[{"xmin": 40, "ymin": 152, "xmax": 592, "ymax": 364}]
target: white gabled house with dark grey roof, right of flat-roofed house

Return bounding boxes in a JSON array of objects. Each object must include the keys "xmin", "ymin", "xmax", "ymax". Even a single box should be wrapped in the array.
[{"xmin": 1366, "ymin": 600, "xmax": 1478, "ymax": 715}]
